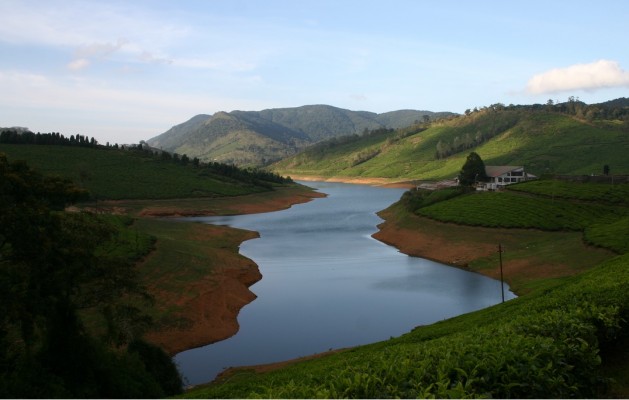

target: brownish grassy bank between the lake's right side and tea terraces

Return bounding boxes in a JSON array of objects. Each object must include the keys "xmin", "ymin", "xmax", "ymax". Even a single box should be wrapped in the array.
[{"xmin": 380, "ymin": 198, "xmax": 614, "ymax": 295}]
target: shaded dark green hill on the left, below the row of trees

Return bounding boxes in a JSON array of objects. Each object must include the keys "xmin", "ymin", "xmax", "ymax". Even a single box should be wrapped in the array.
[{"xmin": 0, "ymin": 143, "xmax": 288, "ymax": 200}]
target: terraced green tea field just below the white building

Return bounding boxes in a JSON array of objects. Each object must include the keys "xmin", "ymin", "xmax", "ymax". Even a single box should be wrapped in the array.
[{"xmin": 404, "ymin": 180, "xmax": 629, "ymax": 253}]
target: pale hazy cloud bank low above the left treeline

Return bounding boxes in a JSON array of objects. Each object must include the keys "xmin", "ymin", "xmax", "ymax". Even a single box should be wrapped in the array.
[{"xmin": 0, "ymin": 70, "xmax": 268, "ymax": 143}]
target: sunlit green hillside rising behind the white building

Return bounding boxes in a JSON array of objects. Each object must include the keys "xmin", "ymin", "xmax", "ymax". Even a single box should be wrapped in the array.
[{"xmin": 270, "ymin": 104, "xmax": 629, "ymax": 180}]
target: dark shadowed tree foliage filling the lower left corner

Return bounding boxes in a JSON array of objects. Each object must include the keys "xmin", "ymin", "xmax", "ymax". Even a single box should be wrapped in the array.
[{"xmin": 0, "ymin": 153, "xmax": 182, "ymax": 398}]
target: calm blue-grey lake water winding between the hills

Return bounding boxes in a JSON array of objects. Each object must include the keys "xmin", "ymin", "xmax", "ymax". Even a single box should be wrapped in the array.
[{"xmin": 175, "ymin": 182, "xmax": 515, "ymax": 385}]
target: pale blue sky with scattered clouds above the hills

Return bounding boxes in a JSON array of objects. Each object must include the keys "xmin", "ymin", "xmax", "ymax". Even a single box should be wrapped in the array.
[{"xmin": 0, "ymin": 0, "xmax": 629, "ymax": 144}]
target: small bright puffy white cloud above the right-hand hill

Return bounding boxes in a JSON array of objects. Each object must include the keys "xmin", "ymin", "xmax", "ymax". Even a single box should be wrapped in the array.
[{"xmin": 526, "ymin": 60, "xmax": 629, "ymax": 94}]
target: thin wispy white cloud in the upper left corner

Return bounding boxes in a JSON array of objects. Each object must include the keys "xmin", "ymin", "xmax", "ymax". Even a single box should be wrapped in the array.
[{"xmin": 0, "ymin": 0, "xmax": 184, "ymax": 69}]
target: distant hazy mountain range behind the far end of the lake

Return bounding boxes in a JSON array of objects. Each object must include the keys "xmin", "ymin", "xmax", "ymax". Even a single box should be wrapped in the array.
[{"xmin": 147, "ymin": 105, "xmax": 455, "ymax": 166}]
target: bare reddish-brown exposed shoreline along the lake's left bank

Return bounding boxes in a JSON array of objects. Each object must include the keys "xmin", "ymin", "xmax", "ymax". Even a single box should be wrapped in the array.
[{"xmin": 138, "ymin": 189, "xmax": 325, "ymax": 356}]
